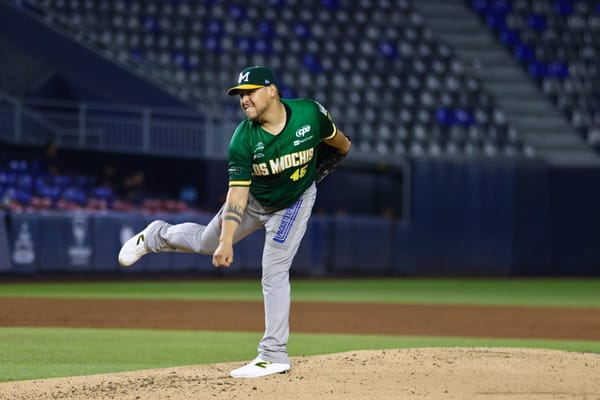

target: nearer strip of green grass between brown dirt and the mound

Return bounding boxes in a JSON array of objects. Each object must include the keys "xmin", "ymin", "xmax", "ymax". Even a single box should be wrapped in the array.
[{"xmin": 0, "ymin": 328, "xmax": 600, "ymax": 382}]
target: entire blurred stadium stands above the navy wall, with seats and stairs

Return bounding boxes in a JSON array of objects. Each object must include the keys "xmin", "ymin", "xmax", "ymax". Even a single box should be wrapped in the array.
[{"xmin": 0, "ymin": 0, "xmax": 600, "ymax": 217}]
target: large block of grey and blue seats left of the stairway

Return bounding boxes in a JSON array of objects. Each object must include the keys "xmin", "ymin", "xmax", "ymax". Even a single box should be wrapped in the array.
[{"xmin": 19, "ymin": 0, "xmax": 536, "ymax": 161}]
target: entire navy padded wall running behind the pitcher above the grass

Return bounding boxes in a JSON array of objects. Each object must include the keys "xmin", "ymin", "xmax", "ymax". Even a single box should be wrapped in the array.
[{"xmin": 0, "ymin": 160, "xmax": 600, "ymax": 276}]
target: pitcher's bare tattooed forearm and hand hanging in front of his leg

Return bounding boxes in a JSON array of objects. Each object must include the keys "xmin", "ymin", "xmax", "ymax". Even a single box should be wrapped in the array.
[{"xmin": 213, "ymin": 186, "xmax": 250, "ymax": 267}]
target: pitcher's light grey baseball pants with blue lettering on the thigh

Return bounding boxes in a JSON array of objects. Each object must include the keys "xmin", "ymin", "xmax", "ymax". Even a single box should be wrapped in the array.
[{"xmin": 147, "ymin": 183, "xmax": 317, "ymax": 364}]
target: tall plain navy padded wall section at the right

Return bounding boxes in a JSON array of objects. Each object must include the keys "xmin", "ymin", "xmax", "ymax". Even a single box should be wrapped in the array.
[{"xmin": 402, "ymin": 160, "xmax": 600, "ymax": 276}]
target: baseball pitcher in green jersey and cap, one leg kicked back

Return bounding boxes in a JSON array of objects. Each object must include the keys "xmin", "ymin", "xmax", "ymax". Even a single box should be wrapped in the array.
[{"xmin": 119, "ymin": 66, "xmax": 351, "ymax": 378}]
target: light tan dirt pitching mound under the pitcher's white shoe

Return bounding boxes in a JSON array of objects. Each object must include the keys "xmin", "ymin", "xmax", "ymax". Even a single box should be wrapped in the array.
[{"xmin": 0, "ymin": 348, "xmax": 600, "ymax": 400}]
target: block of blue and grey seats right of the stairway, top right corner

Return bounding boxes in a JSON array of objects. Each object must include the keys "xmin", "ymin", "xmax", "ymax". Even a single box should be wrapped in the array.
[{"xmin": 471, "ymin": 0, "xmax": 600, "ymax": 147}]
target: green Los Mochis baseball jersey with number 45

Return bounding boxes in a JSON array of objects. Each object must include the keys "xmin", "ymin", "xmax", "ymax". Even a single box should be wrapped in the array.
[{"xmin": 229, "ymin": 99, "xmax": 337, "ymax": 209}]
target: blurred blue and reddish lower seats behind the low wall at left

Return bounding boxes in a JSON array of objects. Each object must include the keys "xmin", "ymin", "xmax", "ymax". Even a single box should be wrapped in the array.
[{"xmin": 0, "ymin": 144, "xmax": 200, "ymax": 212}]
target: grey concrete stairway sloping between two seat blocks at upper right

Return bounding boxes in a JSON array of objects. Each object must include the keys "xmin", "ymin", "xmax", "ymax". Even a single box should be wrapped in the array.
[{"xmin": 414, "ymin": 0, "xmax": 600, "ymax": 165}]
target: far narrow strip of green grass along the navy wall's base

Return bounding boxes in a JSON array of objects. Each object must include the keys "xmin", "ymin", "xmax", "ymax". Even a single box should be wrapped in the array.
[{"xmin": 0, "ymin": 278, "xmax": 600, "ymax": 307}]
